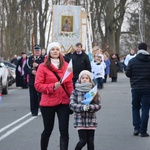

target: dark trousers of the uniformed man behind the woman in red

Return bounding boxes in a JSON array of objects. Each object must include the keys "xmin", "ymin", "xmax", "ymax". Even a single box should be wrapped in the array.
[{"xmin": 29, "ymin": 85, "xmax": 41, "ymax": 115}]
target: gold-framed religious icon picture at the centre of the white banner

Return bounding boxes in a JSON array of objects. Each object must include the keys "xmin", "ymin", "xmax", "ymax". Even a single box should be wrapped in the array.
[{"xmin": 61, "ymin": 16, "xmax": 73, "ymax": 32}]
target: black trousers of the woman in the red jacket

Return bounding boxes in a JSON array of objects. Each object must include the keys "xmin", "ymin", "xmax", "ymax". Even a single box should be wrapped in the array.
[{"xmin": 41, "ymin": 104, "xmax": 69, "ymax": 150}]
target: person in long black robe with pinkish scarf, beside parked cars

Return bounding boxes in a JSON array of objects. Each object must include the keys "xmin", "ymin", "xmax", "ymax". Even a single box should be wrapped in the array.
[{"xmin": 16, "ymin": 52, "xmax": 28, "ymax": 89}]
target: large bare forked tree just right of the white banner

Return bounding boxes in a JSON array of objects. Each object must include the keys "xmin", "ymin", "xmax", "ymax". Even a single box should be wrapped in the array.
[{"xmin": 91, "ymin": 0, "xmax": 127, "ymax": 53}]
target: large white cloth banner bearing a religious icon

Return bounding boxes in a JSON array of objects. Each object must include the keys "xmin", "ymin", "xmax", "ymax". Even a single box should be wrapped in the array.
[{"xmin": 52, "ymin": 5, "xmax": 81, "ymax": 50}]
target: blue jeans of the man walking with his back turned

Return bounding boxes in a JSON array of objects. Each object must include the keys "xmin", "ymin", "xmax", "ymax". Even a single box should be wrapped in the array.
[{"xmin": 131, "ymin": 89, "xmax": 150, "ymax": 133}]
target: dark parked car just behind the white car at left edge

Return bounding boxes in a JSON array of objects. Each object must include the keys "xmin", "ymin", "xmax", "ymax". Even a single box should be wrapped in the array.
[{"xmin": 3, "ymin": 60, "xmax": 16, "ymax": 86}]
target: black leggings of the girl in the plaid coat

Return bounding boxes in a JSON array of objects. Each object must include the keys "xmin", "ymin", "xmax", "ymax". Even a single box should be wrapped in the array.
[{"xmin": 75, "ymin": 130, "xmax": 95, "ymax": 150}]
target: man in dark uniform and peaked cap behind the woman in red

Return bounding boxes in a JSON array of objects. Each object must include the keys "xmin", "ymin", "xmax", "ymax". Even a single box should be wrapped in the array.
[{"xmin": 24, "ymin": 45, "xmax": 44, "ymax": 116}]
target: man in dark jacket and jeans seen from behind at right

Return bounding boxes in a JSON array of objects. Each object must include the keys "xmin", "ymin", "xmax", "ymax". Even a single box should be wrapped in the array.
[{"xmin": 126, "ymin": 43, "xmax": 150, "ymax": 137}]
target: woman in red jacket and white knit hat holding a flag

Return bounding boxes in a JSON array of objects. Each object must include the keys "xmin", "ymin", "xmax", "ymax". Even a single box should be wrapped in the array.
[{"xmin": 34, "ymin": 42, "xmax": 73, "ymax": 150}]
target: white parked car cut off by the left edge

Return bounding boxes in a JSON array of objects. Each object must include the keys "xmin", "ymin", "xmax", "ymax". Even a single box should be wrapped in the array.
[{"xmin": 0, "ymin": 62, "xmax": 9, "ymax": 94}]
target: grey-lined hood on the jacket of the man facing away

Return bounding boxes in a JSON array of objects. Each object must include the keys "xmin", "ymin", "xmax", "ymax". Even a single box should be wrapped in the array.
[{"xmin": 136, "ymin": 50, "xmax": 150, "ymax": 62}]
